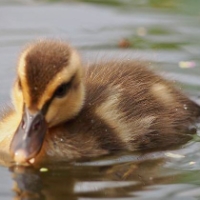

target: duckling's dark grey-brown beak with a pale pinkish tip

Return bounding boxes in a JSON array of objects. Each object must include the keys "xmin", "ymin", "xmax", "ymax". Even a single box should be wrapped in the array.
[{"xmin": 10, "ymin": 108, "xmax": 47, "ymax": 163}]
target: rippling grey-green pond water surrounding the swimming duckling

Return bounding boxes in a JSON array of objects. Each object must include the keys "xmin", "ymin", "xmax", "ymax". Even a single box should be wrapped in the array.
[{"xmin": 0, "ymin": 0, "xmax": 200, "ymax": 200}]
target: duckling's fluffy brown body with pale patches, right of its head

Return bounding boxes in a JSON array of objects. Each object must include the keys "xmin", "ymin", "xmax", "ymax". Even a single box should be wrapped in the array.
[{"xmin": 42, "ymin": 61, "xmax": 200, "ymax": 160}]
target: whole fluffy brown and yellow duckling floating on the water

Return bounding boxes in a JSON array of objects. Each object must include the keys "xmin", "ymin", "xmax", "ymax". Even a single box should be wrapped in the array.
[{"xmin": 0, "ymin": 40, "xmax": 200, "ymax": 164}]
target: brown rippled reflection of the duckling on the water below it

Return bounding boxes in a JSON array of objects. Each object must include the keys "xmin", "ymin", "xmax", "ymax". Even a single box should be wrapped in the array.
[{"xmin": 10, "ymin": 155, "xmax": 181, "ymax": 200}]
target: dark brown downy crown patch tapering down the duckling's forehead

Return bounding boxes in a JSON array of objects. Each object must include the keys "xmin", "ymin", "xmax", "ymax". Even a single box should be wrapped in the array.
[{"xmin": 25, "ymin": 41, "xmax": 70, "ymax": 104}]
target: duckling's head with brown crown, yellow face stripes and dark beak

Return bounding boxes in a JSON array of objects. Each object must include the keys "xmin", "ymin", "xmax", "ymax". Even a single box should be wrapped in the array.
[{"xmin": 10, "ymin": 41, "xmax": 84, "ymax": 163}]
